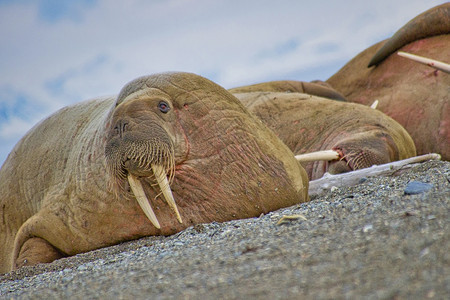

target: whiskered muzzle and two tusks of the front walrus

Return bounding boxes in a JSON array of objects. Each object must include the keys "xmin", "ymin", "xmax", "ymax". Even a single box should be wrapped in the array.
[{"xmin": 105, "ymin": 135, "xmax": 182, "ymax": 229}]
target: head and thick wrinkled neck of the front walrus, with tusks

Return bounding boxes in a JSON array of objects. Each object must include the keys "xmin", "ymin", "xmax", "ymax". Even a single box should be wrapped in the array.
[{"xmin": 105, "ymin": 73, "xmax": 307, "ymax": 234}]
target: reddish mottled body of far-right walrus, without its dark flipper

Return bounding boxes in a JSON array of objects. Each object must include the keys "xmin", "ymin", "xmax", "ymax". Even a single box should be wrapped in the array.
[{"xmin": 327, "ymin": 35, "xmax": 450, "ymax": 160}]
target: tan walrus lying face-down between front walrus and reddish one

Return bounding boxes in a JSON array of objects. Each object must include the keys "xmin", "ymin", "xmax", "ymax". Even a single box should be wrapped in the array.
[{"xmin": 234, "ymin": 92, "xmax": 416, "ymax": 180}]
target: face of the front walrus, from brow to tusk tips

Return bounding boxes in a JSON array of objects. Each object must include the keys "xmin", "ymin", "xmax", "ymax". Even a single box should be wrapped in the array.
[{"xmin": 105, "ymin": 80, "xmax": 182, "ymax": 228}]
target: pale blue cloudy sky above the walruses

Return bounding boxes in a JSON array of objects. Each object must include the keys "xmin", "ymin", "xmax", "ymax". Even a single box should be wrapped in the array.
[{"xmin": 0, "ymin": 0, "xmax": 445, "ymax": 164}]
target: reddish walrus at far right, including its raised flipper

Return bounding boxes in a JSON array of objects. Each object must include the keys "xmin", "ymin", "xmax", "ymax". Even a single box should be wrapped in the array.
[{"xmin": 326, "ymin": 3, "xmax": 450, "ymax": 160}]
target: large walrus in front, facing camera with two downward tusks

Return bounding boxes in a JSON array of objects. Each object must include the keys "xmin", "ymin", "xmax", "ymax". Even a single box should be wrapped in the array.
[{"xmin": 0, "ymin": 73, "xmax": 309, "ymax": 272}]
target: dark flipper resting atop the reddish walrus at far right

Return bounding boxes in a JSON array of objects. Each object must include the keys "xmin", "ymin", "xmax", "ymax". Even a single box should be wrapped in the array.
[{"xmin": 367, "ymin": 2, "xmax": 450, "ymax": 68}]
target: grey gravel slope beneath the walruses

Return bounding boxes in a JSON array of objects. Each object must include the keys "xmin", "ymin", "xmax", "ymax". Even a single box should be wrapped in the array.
[{"xmin": 0, "ymin": 161, "xmax": 450, "ymax": 299}]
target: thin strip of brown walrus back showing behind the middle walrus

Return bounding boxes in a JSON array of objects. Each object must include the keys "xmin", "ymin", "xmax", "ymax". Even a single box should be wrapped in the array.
[{"xmin": 228, "ymin": 80, "xmax": 347, "ymax": 101}]
